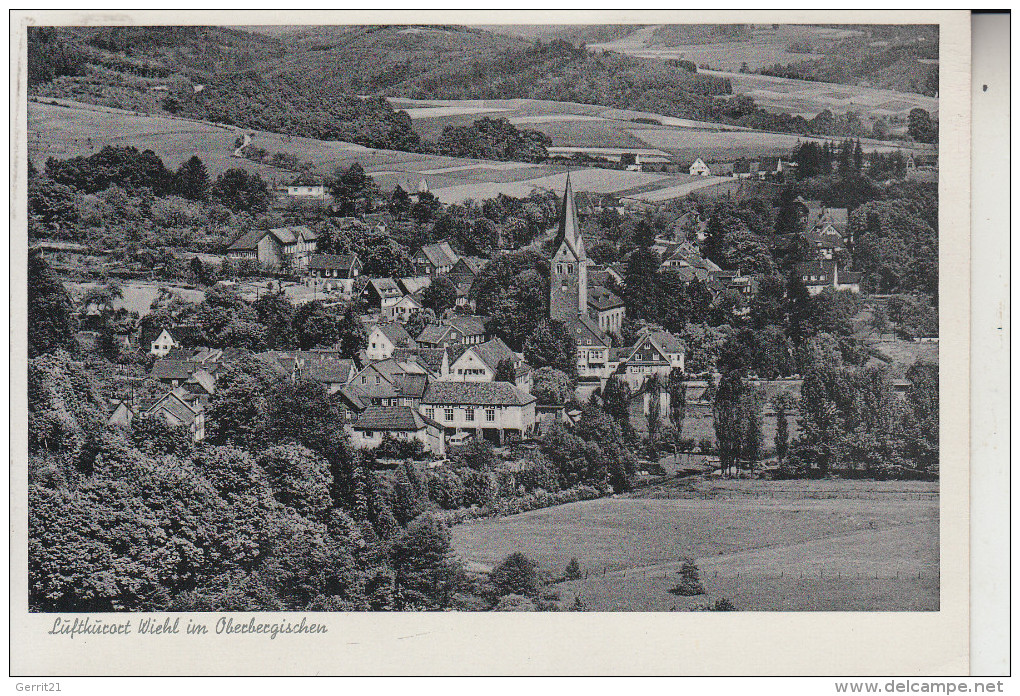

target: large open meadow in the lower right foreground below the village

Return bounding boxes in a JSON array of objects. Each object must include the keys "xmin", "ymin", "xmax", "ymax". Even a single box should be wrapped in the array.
[{"xmin": 452, "ymin": 473, "xmax": 939, "ymax": 611}]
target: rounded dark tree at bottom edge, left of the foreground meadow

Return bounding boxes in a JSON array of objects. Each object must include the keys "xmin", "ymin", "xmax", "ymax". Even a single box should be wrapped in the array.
[{"xmin": 390, "ymin": 514, "xmax": 457, "ymax": 610}]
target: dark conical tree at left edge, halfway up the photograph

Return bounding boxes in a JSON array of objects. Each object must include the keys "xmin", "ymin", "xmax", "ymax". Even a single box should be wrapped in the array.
[{"xmin": 28, "ymin": 251, "xmax": 74, "ymax": 357}]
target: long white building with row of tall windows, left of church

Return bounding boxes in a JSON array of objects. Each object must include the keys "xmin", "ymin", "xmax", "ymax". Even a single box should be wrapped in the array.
[{"xmin": 419, "ymin": 382, "xmax": 537, "ymax": 445}]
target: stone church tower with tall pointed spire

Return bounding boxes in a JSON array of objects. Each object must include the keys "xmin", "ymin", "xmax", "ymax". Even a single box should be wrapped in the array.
[{"xmin": 549, "ymin": 172, "xmax": 590, "ymax": 325}]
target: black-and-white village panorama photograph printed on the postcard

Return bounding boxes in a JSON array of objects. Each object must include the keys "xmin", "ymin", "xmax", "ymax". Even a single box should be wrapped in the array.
[{"xmin": 20, "ymin": 23, "xmax": 940, "ymax": 612}]
